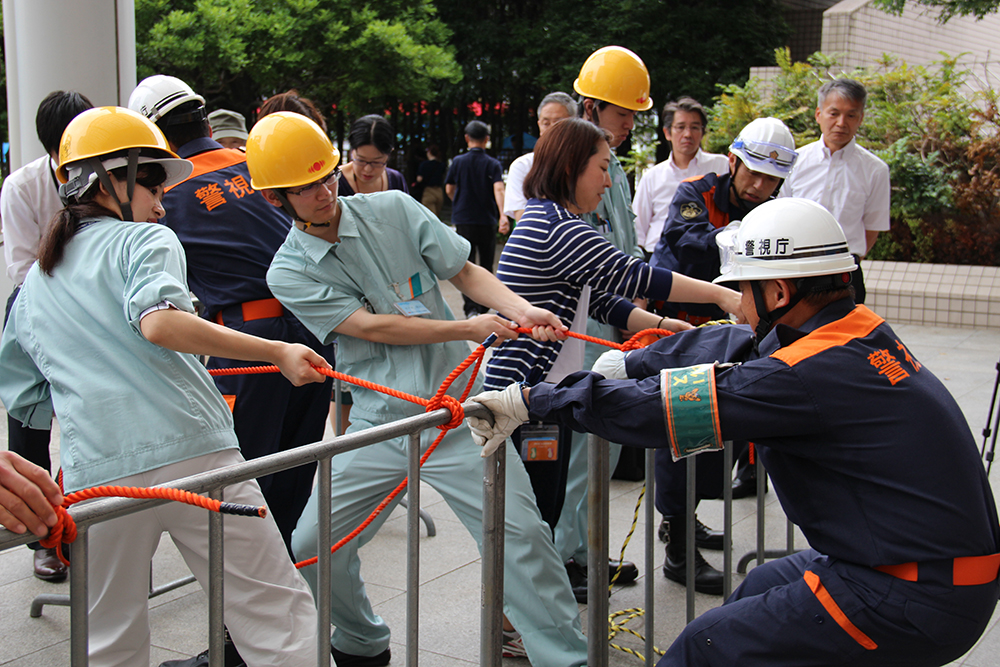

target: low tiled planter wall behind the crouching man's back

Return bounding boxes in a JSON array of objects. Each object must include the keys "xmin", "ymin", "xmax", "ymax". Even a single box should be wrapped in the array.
[{"xmin": 861, "ymin": 260, "xmax": 1000, "ymax": 329}]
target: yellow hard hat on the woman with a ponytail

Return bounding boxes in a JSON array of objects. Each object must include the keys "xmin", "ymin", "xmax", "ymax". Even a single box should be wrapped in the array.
[{"xmin": 56, "ymin": 107, "xmax": 184, "ymax": 183}]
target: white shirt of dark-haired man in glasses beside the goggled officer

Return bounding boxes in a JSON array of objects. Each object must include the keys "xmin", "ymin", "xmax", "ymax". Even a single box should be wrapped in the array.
[{"xmin": 632, "ymin": 148, "xmax": 729, "ymax": 252}]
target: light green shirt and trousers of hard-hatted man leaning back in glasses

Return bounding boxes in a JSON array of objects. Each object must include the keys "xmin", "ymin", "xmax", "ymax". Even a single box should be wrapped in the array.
[{"xmin": 267, "ymin": 191, "xmax": 587, "ymax": 667}]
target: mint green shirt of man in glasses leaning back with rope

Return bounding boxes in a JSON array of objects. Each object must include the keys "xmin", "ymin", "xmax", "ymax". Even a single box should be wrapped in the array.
[{"xmin": 267, "ymin": 190, "xmax": 479, "ymax": 423}]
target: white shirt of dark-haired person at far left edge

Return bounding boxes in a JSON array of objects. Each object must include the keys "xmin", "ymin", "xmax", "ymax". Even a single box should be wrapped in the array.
[{"xmin": 0, "ymin": 155, "xmax": 63, "ymax": 285}]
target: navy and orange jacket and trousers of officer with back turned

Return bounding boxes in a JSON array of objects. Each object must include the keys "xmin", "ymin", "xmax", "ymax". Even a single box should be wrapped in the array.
[{"xmin": 163, "ymin": 138, "xmax": 333, "ymax": 544}]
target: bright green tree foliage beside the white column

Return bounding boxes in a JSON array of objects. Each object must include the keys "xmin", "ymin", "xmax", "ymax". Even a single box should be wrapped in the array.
[{"xmin": 135, "ymin": 0, "xmax": 461, "ymax": 124}]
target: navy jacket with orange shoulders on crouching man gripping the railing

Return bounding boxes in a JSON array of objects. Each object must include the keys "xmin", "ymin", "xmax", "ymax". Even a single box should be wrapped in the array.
[{"xmin": 530, "ymin": 299, "xmax": 1000, "ymax": 568}]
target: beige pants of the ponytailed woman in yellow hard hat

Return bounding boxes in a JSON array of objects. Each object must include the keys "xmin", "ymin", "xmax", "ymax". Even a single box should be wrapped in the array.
[{"xmin": 88, "ymin": 449, "xmax": 318, "ymax": 667}]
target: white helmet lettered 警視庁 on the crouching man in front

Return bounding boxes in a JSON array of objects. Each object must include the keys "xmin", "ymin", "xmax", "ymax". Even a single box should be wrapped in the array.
[{"xmin": 713, "ymin": 197, "xmax": 857, "ymax": 287}]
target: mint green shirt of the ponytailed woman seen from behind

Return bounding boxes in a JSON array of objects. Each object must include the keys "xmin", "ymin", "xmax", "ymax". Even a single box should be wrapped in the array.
[{"xmin": 0, "ymin": 218, "xmax": 238, "ymax": 493}]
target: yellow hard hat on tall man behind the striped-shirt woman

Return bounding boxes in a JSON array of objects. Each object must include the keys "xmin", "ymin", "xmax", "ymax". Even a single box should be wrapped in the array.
[{"xmin": 573, "ymin": 46, "xmax": 653, "ymax": 111}]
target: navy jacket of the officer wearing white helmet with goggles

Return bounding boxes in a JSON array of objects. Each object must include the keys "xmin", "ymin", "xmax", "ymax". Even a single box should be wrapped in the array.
[{"xmin": 649, "ymin": 173, "xmax": 743, "ymax": 324}]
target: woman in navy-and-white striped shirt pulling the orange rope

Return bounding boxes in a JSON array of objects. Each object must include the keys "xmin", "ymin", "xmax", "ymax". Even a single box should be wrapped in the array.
[{"xmin": 485, "ymin": 118, "xmax": 740, "ymax": 528}]
